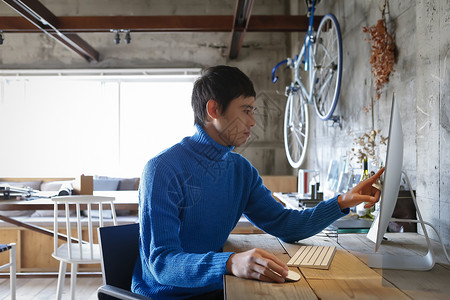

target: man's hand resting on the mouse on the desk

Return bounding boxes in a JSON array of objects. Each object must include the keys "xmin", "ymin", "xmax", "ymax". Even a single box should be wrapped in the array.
[{"xmin": 227, "ymin": 248, "xmax": 289, "ymax": 283}]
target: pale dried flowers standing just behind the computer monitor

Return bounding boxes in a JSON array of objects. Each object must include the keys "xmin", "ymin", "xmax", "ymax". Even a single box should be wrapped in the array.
[{"xmin": 350, "ymin": 130, "xmax": 388, "ymax": 166}]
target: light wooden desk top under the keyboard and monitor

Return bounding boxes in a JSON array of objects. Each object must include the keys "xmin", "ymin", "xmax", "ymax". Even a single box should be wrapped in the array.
[{"xmin": 224, "ymin": 233, "xmax": 450, "ymax": 300}]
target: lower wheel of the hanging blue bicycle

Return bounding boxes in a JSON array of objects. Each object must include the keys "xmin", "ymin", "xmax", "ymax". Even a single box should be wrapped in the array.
[{"xmin": 284, "ymin": 91, "xmax": 309, "ymax": 168}]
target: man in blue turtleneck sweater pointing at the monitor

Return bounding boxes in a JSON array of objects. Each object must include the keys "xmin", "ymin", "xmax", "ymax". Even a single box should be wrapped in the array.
[{"xmin": 132, "ymin": 66, "xmax": 383, "ymax": 299}]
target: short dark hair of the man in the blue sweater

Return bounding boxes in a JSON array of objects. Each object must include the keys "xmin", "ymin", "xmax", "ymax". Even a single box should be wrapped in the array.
[{"xmin": 191, "ymin": 66, "xmax": 256, "ymax": 127}]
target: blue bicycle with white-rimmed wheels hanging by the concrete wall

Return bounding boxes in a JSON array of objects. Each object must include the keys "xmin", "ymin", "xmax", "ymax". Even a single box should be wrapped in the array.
[{"xmin": 272, "ymin": 0, "xmax": 342, "ymax": 168}]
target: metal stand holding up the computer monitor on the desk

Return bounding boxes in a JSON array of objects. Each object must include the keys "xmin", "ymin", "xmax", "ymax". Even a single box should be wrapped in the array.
[{"xmin": 367, "ymin": 172, "xmax": 436, "ymax": 271}]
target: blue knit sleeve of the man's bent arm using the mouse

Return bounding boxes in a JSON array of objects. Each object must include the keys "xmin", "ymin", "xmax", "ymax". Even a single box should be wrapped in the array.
[{"xmin": 139, "ymin": 160, "xmax": 232, "ymax": 288}]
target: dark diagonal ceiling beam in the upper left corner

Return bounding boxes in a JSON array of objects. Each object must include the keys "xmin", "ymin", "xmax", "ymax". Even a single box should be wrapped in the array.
[{"xmin": 0, "ymin": 0, "xmax": 99, "ymax": 62}]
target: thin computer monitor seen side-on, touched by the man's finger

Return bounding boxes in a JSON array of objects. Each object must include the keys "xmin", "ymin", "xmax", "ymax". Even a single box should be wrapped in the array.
[{"xmin": 367, "ymin": 95, "xmax": 403, "ymax": 252}]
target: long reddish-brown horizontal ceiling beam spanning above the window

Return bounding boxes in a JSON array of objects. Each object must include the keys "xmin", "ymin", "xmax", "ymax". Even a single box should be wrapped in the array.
[{"xmin": 0, "ymin": 15, "xmax": 322, "ymax": 33}]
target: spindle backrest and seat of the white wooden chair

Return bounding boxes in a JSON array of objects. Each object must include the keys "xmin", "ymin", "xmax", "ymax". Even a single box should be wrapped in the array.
[{"xmin": 52, "ymin": 195, "xmax": 117, "ymax": 261}]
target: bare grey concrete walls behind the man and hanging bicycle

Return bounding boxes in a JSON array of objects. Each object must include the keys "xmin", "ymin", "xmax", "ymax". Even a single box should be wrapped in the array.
[{"xmin": 0, "ymin": 0, "xmax": 450, "ymax": 245}]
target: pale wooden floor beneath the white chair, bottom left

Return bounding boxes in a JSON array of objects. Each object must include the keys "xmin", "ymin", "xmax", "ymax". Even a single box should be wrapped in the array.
[{"xmin": 0, "ymin": 277, "xmax": 102, "ymax": 300}]
